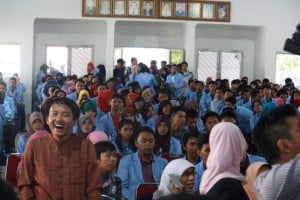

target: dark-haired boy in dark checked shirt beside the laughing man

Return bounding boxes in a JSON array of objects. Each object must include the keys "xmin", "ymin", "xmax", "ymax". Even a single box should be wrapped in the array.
[{"xmin": 95, "ymin": 141, "xmax": 122, "ymax": 199}]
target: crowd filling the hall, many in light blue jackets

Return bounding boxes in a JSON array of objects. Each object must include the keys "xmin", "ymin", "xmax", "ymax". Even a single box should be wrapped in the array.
[{"xmin": 0, "ymin": 57, "xmax": 300, "ymax": 200}]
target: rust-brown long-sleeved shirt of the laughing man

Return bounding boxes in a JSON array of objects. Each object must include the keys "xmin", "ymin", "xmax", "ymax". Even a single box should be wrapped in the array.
[{"xmin": 18, "ymin": 134, "xmax": 101, "ymax": 200}]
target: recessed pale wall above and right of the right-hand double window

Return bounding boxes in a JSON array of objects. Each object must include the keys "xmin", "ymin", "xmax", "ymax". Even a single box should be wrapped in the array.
[{"xmin": 196, "ymin": 24, "xmax": 260, "ymax": 80}]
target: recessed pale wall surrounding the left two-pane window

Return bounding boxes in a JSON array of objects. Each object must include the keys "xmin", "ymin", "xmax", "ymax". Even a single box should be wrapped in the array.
[{"xmin": 33, "ymin": 19, "xmax": 106, "ymax": 78}]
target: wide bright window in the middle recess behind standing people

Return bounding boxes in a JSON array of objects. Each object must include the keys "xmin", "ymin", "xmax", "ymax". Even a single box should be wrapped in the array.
[{"xmin": 114, "ymin": 47, "xmax": 184, "ymax": 68}]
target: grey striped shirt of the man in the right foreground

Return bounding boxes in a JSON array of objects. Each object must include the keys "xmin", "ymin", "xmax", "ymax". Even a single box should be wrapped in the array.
[{"xmin": 254, "ymin": 154, "xmax": 300, "ymax": 200}]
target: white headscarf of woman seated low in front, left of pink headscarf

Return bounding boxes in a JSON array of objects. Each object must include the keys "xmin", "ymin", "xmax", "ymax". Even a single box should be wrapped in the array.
[{"xmin": 158, "ymin": 159, "xmax": 195, "ymax": 196}]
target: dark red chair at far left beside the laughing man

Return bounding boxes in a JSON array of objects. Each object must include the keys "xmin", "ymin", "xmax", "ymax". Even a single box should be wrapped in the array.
[{"xmin": 5, "ymin": 154, "xmax": 22, "ymax": 187}]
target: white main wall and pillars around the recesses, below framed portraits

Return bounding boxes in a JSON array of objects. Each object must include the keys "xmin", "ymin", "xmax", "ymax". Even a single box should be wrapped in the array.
[{"xmin": 0, "ymin": 0, "xmax": 300, "ymax": 112}]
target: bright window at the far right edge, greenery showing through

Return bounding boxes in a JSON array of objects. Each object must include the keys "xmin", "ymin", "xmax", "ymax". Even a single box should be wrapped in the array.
[{"xmin": 276, "ymin": 53, "xmax": 300, "ymax": 86}]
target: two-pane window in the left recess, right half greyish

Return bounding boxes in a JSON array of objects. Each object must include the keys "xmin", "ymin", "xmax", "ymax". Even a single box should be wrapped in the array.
[{"xmin": 47, "ymin": 46, "xmax": 93, "ymax": 77}]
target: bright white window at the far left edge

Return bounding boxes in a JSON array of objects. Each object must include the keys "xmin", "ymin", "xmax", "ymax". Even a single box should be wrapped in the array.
[{"xmin": 0, "ymin": 44, "xmax": 21, "ymax": 79}]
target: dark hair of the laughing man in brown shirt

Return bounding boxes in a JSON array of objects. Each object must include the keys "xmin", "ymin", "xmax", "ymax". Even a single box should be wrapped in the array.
[{"xmin": 42, "ymin": 97, "xmax": 80, "ymax": 121}]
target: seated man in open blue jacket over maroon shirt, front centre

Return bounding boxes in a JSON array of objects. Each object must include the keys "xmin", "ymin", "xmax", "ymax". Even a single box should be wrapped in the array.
[{"xmin": 118, "ymin": 126, "xmax": 167, "ymax": 200}]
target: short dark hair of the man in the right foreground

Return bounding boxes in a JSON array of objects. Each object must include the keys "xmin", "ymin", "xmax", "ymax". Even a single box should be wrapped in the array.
[{"xmin": 253, "ymin": 105, "xmax": 297, "ymax": 164}]
